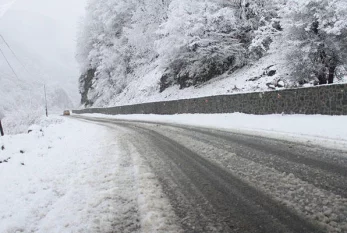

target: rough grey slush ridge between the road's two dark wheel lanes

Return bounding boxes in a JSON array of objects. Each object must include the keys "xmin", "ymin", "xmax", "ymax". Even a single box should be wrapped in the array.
[{"xmin": 151, "ymin": 124, "xmax": 347, "ymax": 232}]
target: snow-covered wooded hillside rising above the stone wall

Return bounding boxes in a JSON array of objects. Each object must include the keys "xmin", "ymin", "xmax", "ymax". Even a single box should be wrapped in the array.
[{"xmin": 76, "ymin": 0, "xmax": 347, "ymax": 106}]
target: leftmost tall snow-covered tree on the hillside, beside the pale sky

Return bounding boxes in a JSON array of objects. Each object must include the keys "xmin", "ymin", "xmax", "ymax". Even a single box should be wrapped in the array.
[{"xmin": 77, "ymin": 0, "xmax": 133, "ymax": 105}]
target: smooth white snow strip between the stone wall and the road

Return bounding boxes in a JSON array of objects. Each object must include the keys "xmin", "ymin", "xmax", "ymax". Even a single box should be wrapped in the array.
[{"xmin": 83, "ymin": 113, "xmax": 347, "ymax": 150}]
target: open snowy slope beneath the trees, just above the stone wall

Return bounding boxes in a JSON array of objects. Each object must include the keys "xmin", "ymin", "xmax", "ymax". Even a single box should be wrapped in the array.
[{"xmin": 101, "ymin": 36, "xmax": 347, "ymax": 106}]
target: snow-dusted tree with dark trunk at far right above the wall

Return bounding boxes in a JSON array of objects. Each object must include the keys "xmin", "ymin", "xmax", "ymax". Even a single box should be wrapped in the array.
[{"xmin": 288, "ymin": 0, "xmax": 347, "ymax": 84}]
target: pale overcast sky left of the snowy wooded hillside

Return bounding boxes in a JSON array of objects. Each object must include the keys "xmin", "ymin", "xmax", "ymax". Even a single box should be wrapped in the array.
[{"xmin": 0, "ymin": 0, "xmax": 87, "ymax": 104}]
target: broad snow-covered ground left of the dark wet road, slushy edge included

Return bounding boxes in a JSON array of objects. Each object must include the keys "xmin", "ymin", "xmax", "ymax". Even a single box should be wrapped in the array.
[{"xmin": 0, "ymin": 117, "xmax": 179, "ymax": 233}]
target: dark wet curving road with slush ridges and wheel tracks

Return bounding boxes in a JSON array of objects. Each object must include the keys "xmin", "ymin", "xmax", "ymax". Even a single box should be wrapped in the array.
[{"xmin": 74, "ymin": 116, "xmax": 347, "ymax": 233}]
